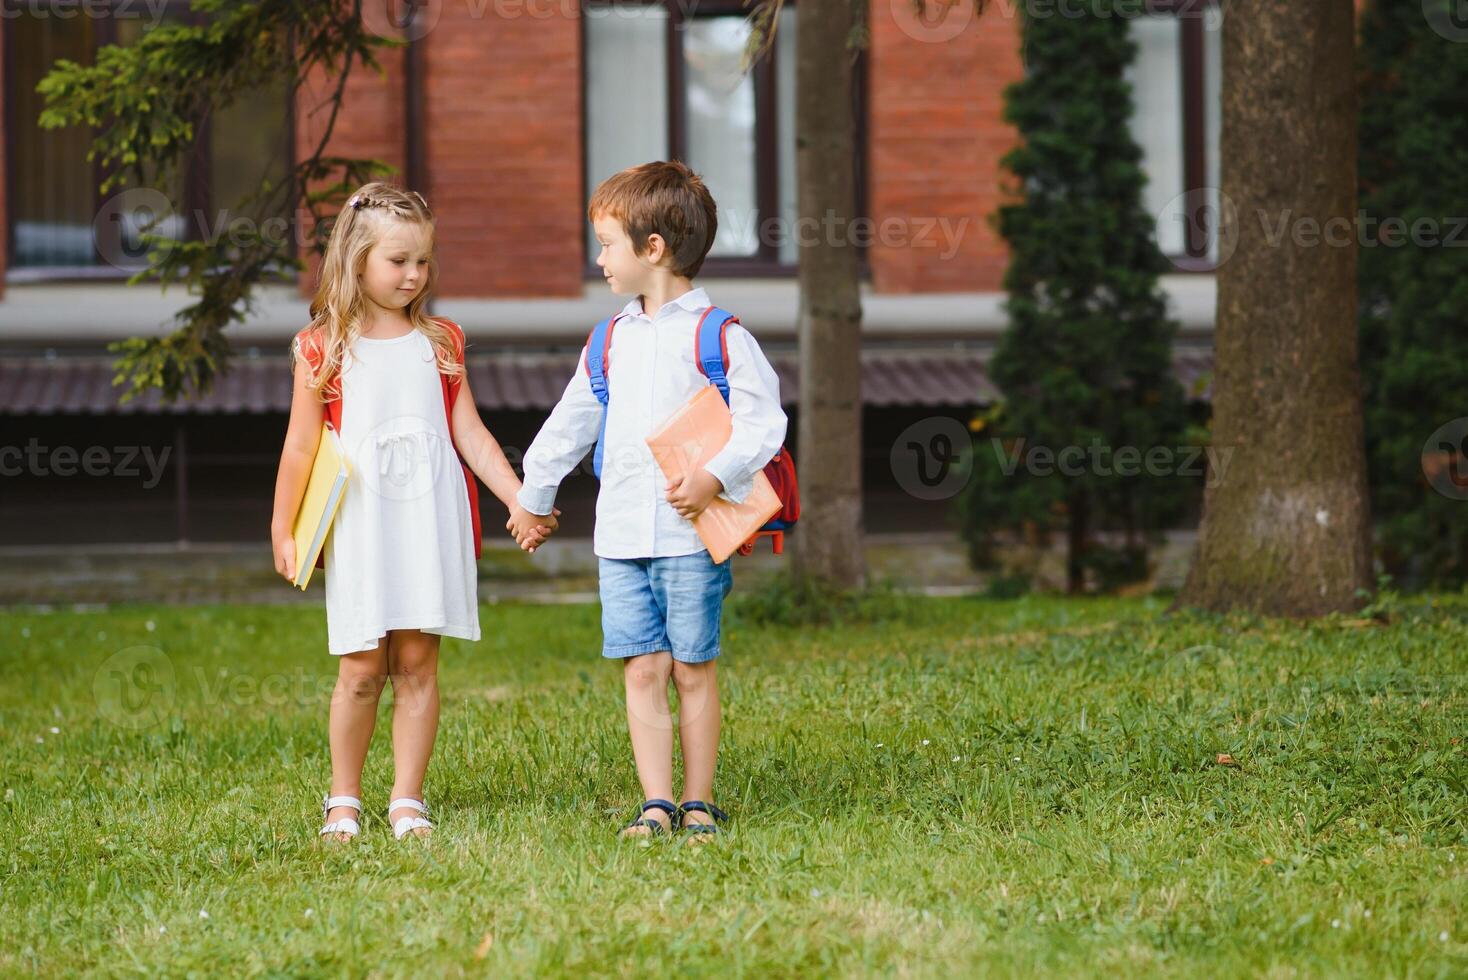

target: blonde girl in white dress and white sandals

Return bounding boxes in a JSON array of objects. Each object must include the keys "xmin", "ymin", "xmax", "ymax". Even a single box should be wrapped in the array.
[{"xmin": 270, "ymin": 182, "xmax": 555, "ymax": 841}]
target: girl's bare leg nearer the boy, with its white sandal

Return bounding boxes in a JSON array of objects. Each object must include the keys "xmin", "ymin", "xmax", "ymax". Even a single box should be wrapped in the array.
[{"xmin": 388, "ymin": 629, "xmax": 440, "ymax": 838}]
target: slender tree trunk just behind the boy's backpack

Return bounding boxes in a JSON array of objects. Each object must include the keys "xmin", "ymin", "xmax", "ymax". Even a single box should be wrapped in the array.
[{"xmin": 794, "ymin": 0, "xmax": 865, "ymax": 588}]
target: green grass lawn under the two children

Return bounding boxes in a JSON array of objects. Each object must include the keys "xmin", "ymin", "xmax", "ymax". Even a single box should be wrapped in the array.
[{"xmin": 0, "ymin": 597, "xmax": 1468, "ymax": 977}]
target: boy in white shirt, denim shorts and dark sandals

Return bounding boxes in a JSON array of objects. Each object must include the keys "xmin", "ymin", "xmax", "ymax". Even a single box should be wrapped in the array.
[{"xmin": 506, "ymin": 161, "xmax": 785, "ymax": 841}]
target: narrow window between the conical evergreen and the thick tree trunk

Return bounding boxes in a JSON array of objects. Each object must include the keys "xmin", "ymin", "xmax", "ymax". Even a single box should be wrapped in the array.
[{"xmin": 1127, "ymin": 0, "xmax": 1223, "ymax": 270}]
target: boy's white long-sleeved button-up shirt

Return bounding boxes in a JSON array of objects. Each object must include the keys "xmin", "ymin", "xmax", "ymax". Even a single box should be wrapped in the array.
[{"xmin": 518, "ymin": 289, "xmax": 785, "ymax": 557}]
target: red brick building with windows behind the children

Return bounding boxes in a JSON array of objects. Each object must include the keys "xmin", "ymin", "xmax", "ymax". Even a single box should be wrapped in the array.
[{"xmin": 0, "ymin": 0, "xmax": 1218, "ymax": 543}]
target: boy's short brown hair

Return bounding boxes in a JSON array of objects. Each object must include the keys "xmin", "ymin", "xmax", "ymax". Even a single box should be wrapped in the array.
[{"xmin": 586, "ymin": 160, "xmax": 719, "ymax": 279}]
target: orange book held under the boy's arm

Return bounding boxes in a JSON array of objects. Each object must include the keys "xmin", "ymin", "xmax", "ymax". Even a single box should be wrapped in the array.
[{"xmin": 647, "ymin": 384, "xmax": 781, "ymax": 562}]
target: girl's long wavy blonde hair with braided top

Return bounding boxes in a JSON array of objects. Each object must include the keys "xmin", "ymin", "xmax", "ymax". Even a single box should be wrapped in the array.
[{"xmin": 291, "ymin": 180, "xmax": 464, "ymax": 402}]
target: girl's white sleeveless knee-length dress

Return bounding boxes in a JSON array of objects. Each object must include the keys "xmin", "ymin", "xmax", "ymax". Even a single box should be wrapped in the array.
[{"xmin": 324, "ymin": 330, "xmax": 479, "ymax": 654}]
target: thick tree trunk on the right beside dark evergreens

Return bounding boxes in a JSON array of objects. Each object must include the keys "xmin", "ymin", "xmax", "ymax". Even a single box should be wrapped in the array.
[{"xmin": 1176, "ymin": 0, "xmax": 1371, "ymax": 616}]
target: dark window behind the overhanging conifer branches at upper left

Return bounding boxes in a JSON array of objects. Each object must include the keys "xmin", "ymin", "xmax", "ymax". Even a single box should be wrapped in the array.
[{"xmin": 4, "ymin": 0, "xmax": 294, "ymax": 280}]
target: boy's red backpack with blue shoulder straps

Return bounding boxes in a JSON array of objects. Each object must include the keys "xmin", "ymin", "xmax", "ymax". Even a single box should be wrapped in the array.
[{"xmin": 586, "ymin": 307, "xmax": 800, "ymax": 555}]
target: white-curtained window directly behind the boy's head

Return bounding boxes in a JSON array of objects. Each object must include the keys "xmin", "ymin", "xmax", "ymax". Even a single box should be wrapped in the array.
[{"xmin": 583, "ymin": 0, "xmax": 862, "ymax": 274}]
